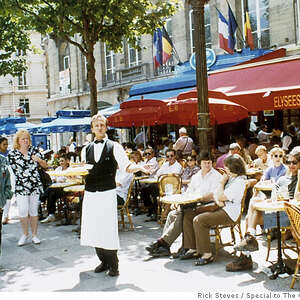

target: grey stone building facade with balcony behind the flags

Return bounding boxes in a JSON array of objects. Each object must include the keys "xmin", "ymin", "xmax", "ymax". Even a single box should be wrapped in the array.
[{"xmin": 45, "ymin": 0, "xmax": 300, "ymax": 122}]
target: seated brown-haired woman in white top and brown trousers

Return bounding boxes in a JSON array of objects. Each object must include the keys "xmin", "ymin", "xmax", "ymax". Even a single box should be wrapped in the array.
[{"xmin": 183, "ymin": 154, "xmax": 246, "ymax": 266}]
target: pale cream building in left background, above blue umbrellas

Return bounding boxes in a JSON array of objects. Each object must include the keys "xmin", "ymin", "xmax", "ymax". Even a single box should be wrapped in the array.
[{"xmin": 0, "ymin": 32, "xmax": 48, "ymax": 123}]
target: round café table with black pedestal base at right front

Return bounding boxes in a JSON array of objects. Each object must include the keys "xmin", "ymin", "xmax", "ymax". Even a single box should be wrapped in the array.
[{"xmin": 254, "ymin": 199, "xmax": 299, "ymax": 279}]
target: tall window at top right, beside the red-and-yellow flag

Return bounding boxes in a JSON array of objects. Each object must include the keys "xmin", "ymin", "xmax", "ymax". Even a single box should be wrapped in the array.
[{"xmin": 242, "ymin": 0, "xmax": 270, "ymax": 48}]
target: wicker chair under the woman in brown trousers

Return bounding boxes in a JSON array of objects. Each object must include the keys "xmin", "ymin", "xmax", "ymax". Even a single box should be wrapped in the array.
[{"xmin": 210, "ymin": 182, "xmax": 248, "ymax": 256}]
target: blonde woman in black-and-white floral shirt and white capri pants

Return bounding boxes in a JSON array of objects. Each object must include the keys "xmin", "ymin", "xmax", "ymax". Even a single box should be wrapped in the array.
[{"xmin": 7, "ymin": 129, "xmax": 47, "ymax": 246}]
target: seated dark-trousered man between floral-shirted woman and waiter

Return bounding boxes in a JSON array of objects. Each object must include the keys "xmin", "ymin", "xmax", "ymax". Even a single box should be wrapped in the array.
[{"xmin": 41, "ymin": 154, "xmax": 80, "ymax": 223}]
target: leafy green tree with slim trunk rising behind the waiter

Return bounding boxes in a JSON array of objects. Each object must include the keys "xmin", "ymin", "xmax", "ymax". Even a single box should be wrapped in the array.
[{"xmin": 0, "ymin": 0, "xmax": 178, "ymax": 115}]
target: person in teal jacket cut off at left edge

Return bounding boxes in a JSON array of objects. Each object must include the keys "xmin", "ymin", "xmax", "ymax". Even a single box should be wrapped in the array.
[{"xmin": 0, "ymin": 155, "xmax": 13, "ymax": 255}]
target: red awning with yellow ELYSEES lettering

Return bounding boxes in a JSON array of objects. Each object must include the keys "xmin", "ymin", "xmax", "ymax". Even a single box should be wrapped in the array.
[{"xmin": 207, "ymin": 58, "xmax": 300, "ymax": 112}]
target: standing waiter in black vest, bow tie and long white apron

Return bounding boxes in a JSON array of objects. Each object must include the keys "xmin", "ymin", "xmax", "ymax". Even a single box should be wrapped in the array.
[{"xmin": 80, "ymin": 114, "xmax": 141, "ymax": 276}]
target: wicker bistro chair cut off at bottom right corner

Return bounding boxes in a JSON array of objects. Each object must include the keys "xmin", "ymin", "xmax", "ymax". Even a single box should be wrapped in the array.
[{"xmin": 284, "ymin": 202, "xmax": 300, "ymax": 289}]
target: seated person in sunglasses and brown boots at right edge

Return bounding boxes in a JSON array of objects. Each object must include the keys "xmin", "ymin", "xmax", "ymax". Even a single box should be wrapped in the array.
[{"xmin": 226, "ymin": 153, "xmax": 300, "ymax": 272}]
